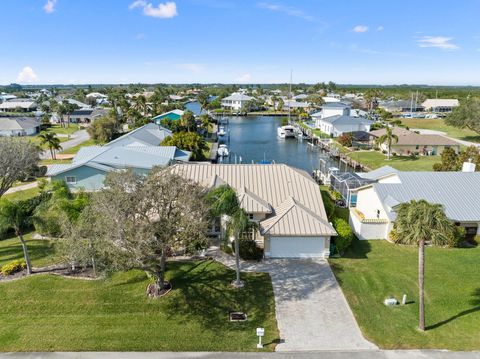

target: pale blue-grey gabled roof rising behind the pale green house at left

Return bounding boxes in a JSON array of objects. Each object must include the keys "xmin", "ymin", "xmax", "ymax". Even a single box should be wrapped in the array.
[{"xmin": 105, "ymin": 123, "xmax": 172, "ymax": 147}]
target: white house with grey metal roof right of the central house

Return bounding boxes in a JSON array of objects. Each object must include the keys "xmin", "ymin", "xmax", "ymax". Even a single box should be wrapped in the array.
[{"xmin": 350, "ymin": 167, "xmax": 480, "ymax": 239}]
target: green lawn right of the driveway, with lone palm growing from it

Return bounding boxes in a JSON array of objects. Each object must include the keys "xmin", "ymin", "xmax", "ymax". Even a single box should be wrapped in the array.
[{"xmin": 329, "ymin": 241, "xmax": 480, "ymax": 350}]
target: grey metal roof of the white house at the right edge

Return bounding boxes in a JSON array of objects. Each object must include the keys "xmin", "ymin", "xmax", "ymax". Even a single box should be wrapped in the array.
[{"xmin": 372, "ymin": 172, "xmax": 480, "ymax": 222}]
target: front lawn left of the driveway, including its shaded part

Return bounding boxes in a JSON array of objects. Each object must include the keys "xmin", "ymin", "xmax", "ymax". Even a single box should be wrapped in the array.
[{"xmin": 0, "ymin": 261, "xmax": 279, "ymax": 352}]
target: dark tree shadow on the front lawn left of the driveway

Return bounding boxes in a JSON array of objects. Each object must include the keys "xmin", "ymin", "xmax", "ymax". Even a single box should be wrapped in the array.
[{"xmin": 165, "ymin": 261, "xmax": 275, "ymax": 332}]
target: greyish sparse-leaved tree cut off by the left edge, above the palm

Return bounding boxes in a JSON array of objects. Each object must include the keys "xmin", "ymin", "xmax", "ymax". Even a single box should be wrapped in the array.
[{"xmin": 0, "ymin": 137, "xmax": 40, "ymax": 197}]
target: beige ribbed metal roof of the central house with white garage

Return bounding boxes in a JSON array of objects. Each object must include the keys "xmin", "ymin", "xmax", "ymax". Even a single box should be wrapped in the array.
[{"xmin": 172, "ymin": 163, "xmax": 336, "ymax": 236}]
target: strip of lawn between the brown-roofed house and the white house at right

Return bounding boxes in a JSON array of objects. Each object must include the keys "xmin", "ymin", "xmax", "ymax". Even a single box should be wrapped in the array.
[{"xmin": 349, "ymin": 151, "xmax": 441, "ymax": 171}]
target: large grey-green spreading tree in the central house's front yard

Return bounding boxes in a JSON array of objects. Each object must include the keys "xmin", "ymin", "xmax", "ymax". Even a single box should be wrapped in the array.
[{"xmin": 88, "ymin": 168, "xmax": 208, "ymax": 296}]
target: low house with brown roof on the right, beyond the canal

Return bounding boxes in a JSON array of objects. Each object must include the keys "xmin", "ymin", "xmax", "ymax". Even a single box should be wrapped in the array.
[{"xmin": 370, "ymin": 127, "xmax": 460, "ymax": 155}]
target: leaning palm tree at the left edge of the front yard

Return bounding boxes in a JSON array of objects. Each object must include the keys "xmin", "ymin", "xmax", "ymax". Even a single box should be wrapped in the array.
[{"xmin": 0, "ymin": 199, "xmax": 32, "ymax": 274}]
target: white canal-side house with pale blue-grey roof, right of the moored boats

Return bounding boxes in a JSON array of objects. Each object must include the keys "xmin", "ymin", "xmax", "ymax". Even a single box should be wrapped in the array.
[{"xmin": 315, "ymin": 115, "xmax": 373, "ymax": 137}]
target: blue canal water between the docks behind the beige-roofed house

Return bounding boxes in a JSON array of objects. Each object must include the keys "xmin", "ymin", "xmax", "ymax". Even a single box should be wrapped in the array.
[{"xmin": 185, "ymin": 102, "xmax": 344, "ymax": 173}]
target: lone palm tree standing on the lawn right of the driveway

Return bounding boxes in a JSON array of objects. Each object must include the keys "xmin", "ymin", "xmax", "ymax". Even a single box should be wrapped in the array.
[{"xmin": 392, "ymin": 200, "xmax": 456, "ymax": 330}]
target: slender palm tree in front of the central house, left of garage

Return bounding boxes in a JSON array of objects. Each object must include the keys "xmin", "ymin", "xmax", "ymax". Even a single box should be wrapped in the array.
[{"xmin": 207, "ymin": 185, "xmax": 249, "ymax": 288}]
